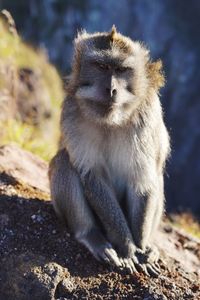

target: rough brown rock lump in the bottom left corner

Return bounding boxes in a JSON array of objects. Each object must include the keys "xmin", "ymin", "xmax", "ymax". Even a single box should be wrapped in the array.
[{"xmin": 0, "ymin": 253, "xmax": 72, "ymax": 300}]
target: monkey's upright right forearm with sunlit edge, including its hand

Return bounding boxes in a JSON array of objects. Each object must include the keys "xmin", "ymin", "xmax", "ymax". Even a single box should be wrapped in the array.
[{"xmin": 126, "ymin": 186, "xmax": 160, "ymax": 276}]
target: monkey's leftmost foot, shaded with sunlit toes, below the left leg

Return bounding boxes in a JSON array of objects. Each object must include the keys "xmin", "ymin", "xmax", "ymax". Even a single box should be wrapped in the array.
[{"xmin": 78, "ymin": 229, "xmax": 121, "ymax": 267}]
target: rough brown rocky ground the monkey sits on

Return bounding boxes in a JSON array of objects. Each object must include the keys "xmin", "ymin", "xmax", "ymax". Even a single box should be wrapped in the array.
[{"xmin": 0, "ymin": 146, "xmax": 200, "ymax": 300}]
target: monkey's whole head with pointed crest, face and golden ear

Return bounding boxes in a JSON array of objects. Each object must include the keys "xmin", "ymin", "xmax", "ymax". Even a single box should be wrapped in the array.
[{"xmin": 69, "ymin": 26, "xmax": 164, "ymax": 126}]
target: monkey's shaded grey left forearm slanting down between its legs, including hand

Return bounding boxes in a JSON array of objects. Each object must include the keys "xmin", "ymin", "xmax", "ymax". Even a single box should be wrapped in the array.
[{"xmin": 82, "ymin": 171, "xmax": 141, "ymax": 272}]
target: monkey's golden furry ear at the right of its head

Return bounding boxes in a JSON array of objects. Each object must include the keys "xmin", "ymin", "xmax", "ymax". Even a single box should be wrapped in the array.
[{"xmin": 147, "ymin": 59, "xmax": 165, "ymax": 91}]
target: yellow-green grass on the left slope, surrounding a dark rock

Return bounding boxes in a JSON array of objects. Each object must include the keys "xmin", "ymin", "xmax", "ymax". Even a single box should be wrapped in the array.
[{"xmin": 0, "ymin": 14, "xmax": 64, "ymax": 161}]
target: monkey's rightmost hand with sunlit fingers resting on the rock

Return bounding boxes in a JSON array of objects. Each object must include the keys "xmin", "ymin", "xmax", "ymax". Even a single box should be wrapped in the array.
[{"xmin": 136, "ymin": 247, "xmax": 160, "ymax": 277}]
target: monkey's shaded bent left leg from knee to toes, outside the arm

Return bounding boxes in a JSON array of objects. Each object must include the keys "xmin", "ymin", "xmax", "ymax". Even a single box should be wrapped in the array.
[{"xmin": 49, "ymin": 149, "xmax": 121, "ymax": 266}]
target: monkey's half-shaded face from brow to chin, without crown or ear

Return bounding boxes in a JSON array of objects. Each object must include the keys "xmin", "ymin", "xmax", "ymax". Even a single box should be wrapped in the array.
[{"xmin": 76, "ymin": 55, "xmax": 149, "ymax": 125}]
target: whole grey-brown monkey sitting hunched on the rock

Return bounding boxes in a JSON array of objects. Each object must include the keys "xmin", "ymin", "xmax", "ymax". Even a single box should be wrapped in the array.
[{"xmin": 49, "ymin": 26, "xmax": 170, "ymax": 276}]
